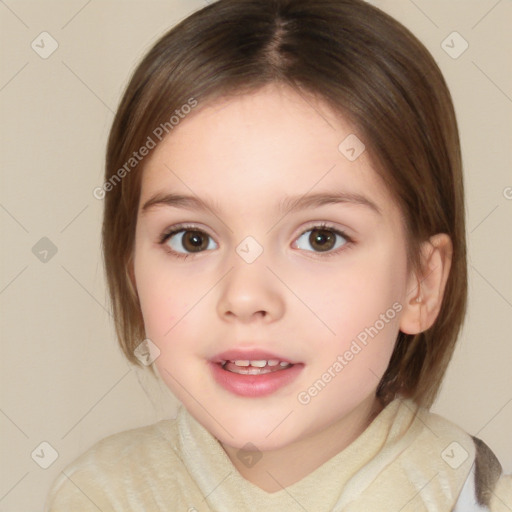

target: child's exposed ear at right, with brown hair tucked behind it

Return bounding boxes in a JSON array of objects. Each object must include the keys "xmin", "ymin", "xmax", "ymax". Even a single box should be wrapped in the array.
[{"xmin": 400, "ymin": 233, "xmax": 453, "ymax": 334}]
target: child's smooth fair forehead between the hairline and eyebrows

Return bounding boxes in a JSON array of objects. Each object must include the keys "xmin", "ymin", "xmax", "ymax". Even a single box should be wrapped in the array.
[{"xmin": 140, "ymin": 85, "xmax": 393, "ymax": 218}]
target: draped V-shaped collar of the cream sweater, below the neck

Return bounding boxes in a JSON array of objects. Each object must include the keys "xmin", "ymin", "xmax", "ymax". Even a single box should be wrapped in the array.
[{"xmin": 177, "ymin": 399, "xmax": 418, "ymax": 512}]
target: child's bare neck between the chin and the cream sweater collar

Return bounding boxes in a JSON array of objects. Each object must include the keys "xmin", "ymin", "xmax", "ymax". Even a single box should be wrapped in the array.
[{"xmin": 218, "ymin": 396, "xmax": 382, "ymax": 493}]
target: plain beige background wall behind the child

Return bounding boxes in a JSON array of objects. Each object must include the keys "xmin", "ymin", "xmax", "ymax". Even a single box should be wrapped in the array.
[{"xmin": 0, "ymin": 0, "xmax": 512, "ymax": 511}]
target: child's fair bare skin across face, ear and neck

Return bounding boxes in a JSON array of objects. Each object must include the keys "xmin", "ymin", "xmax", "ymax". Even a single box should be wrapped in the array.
[{"xmin": 130, "ymin": 85, "xmax": 450, "ymax": 492}]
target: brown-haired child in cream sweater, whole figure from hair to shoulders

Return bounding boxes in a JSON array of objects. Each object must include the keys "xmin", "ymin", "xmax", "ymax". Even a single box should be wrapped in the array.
[{"xmin": 47, "ymin": 0, "xmax": 512, "ymax": 512}]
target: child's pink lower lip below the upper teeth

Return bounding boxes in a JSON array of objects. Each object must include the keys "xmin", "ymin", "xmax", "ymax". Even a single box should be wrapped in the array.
[{"xmin": 210, "ymin": 362, "xmax": 304, "ymax": 397}]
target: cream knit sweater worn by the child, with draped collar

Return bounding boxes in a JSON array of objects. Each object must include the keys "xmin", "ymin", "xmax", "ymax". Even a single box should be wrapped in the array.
[{"xmin": 45, "ymin": 399, "xmax": 512, "ymax": 512}]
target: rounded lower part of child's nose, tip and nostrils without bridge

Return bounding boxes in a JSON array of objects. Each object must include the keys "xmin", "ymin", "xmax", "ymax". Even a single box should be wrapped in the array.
[{"xmin": 217, "ymin": 261, "xmax": 285, "ymax": 323}]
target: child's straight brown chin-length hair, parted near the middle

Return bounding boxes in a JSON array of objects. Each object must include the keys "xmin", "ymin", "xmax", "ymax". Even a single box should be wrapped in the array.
[{"xmin": 103, "ymin": 0, "xmax": 467, "ymax": 406}]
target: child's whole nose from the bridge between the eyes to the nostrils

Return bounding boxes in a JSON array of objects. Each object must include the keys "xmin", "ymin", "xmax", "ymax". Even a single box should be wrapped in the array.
[{"xmin": 217, "ymin": 242, "xmax": 284, "ymax": 322}]
